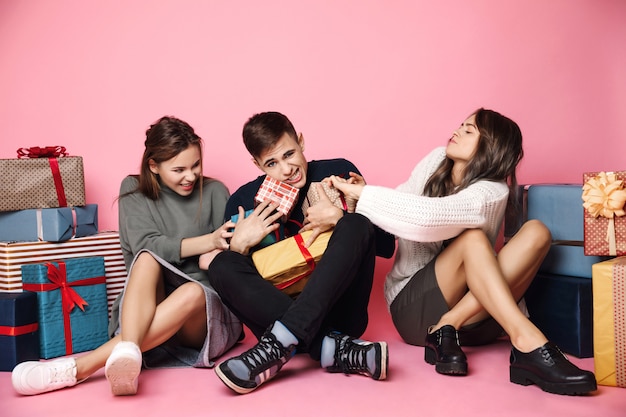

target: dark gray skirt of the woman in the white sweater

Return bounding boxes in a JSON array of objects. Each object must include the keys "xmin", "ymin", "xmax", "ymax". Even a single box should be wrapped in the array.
[{"xmin": 389, "ymin": 257, "xmax": 503, "ymax": 346}]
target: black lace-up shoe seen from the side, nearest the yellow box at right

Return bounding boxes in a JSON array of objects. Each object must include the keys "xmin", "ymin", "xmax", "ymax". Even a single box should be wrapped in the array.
[{"xmin": 510, "ymin": 342, "xmax": 597, "ymax": 395}]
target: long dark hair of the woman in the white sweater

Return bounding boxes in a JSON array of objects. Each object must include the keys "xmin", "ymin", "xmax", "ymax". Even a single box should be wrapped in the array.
[{"xmin": 424, "ymin": 108, "xmax": 524, "ymax": 208}]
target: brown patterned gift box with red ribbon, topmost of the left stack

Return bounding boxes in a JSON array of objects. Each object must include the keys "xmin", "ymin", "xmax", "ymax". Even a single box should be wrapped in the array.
[{"xmin": 0, "ymin": 147, "xmax": 86, "ymax": 211}]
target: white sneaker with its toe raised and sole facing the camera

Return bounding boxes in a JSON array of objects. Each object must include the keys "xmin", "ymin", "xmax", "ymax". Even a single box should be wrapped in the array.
[{"xmin": 104, "ymin": 342, "xmax": 141, "ymax": 395}]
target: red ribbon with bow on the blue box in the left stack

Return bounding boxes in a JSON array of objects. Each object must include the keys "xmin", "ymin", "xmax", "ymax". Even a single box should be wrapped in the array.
[{"xmin": 22, "ymin": 261, "xmax": 106, "ymax": 355}]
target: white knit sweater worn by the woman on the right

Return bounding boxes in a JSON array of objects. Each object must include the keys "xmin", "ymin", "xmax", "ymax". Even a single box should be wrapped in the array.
[{"xmin": 356, "ymin": 147, "xmax": 509, "ymax": 306}]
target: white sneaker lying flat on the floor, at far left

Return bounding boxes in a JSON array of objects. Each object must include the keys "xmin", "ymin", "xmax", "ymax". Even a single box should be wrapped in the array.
[{"xmin": 11, "ymin": 358, "xmax": 78, "ymax": 395}]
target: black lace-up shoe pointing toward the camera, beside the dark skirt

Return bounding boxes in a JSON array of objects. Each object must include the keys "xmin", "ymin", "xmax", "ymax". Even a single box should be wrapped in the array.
[{"xmin": 424, "ymin": 325, "xmax": 467, "ymax": 376}]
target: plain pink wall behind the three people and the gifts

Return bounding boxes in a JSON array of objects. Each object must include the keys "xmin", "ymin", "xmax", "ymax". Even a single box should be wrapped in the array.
[{"xmin": 0, "ymin": 0, "xmax": 626, "ymax": 230}]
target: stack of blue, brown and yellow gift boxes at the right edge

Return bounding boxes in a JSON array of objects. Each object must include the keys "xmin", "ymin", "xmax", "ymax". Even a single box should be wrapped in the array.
[{"xmin": 505, "ymin": 168, "xmax": 626, "ymax": 387}]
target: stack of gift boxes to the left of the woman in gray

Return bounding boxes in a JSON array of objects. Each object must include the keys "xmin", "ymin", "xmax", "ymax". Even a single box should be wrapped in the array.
[{"xmin": 0, "ymin": 146, "xmax": 126, "ymax": 371}]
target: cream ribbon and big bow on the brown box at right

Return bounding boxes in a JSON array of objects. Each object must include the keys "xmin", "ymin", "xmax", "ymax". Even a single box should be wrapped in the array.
[{"xmin": 582, "ymin": 172, "xmax": 626, "ymax": 256}]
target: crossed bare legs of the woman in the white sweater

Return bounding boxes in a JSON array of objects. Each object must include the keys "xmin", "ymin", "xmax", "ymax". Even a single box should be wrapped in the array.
[{"xmin": 433, "ymin": 221, "xmax": 550, "ymax": 352}]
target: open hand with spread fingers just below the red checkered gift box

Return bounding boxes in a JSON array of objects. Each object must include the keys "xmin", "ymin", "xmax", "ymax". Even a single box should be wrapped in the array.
[{"xmin": 230, "ymin": 200, "xmax": 282, "ymax": 255}]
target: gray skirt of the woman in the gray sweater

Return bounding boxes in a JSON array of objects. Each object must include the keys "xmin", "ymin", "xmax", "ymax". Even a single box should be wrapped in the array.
[{"xmin": 109, "ymin": 249, "xmax": 243, "ymax": 368}]
